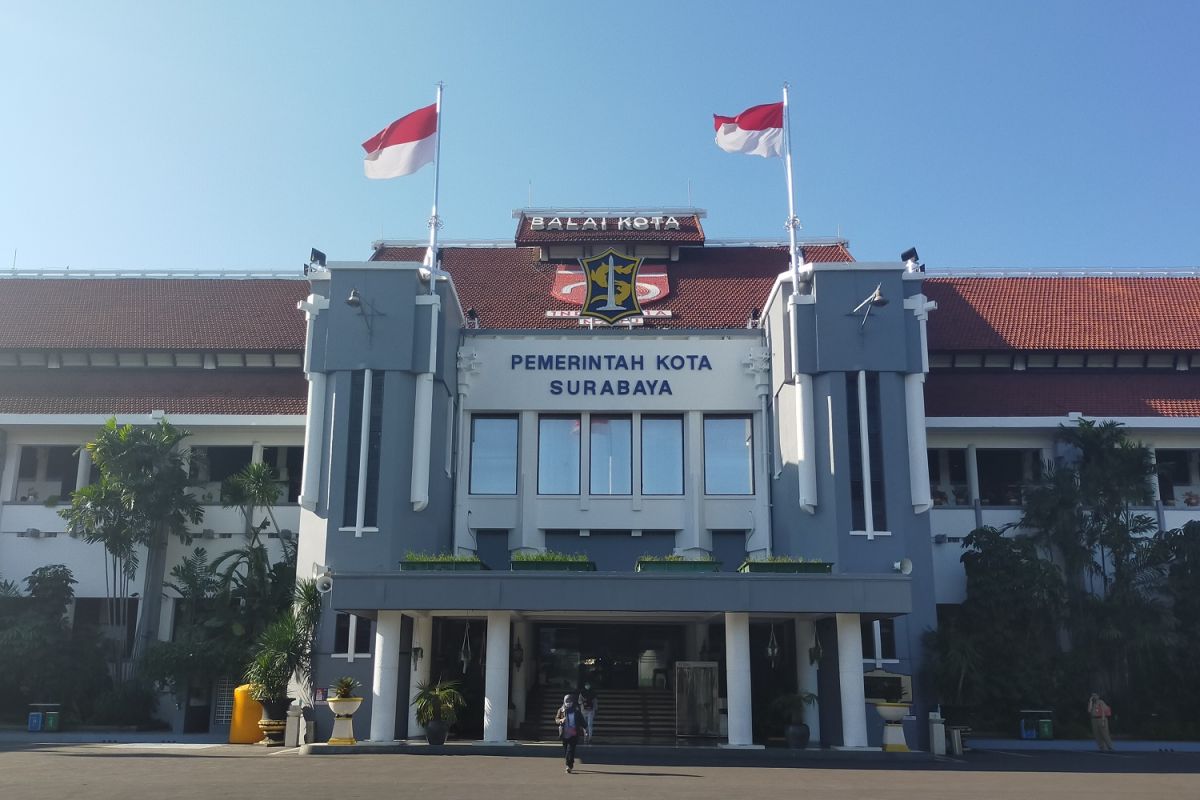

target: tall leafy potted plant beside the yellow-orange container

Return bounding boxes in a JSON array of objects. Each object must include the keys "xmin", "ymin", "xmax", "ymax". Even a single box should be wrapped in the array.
[{"xmin": 244, "ymin": 581, "xmax": 320, "ymax": 746}]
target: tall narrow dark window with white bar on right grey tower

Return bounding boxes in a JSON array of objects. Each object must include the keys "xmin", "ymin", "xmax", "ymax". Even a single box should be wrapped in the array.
[{"xmin": 846, "ymin": 372, "xmax": 888, "ymax": 533}]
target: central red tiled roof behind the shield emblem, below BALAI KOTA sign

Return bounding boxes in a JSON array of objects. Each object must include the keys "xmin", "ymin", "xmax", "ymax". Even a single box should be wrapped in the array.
[{"xmin": 374, "ymin": 245, "xmax": 854, "ymax": 330}]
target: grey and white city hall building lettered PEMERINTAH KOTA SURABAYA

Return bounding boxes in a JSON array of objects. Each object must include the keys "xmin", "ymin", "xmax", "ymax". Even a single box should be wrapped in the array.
[{"xmin": 0, "ymin": 209, "xmax": 1200, "ymax": 747}]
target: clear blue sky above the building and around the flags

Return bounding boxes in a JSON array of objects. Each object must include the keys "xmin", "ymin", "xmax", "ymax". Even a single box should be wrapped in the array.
[{"xmin": 0, "ymin": 0, "xmax": 1200, "ymax": 271}]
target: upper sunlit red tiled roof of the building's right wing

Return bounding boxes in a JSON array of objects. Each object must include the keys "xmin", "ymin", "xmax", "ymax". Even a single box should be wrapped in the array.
[{"xmin": 925, "ymin": 277, "xmax": 1200, "ymax": 350}]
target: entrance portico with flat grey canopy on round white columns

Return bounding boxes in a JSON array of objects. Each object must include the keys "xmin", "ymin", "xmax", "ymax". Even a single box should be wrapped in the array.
[{"xmin": 338, "ymin": 572, "xmax": 908, "ymax": 747}]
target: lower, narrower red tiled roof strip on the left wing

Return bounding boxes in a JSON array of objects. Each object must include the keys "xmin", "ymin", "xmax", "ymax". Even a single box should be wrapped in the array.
[{"xmin": 0, "ymin": 368, "xmax": 307, "ymax": 415}]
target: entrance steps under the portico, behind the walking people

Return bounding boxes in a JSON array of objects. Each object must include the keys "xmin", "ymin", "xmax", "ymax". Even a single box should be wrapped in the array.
[{"xmin": 526, "ymin": 688, "xmax": 676, "ymax": 744}]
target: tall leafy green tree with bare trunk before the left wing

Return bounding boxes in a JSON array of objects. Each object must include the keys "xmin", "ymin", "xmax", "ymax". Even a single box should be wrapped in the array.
[{"xmin": 60, "ymin": 419, "xmax": 204, "ymax": 666}]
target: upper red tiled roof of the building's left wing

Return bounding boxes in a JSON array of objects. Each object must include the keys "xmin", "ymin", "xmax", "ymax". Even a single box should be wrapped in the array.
[{"xmin": 0, "ymin": 278, "xmax": 308, "ymax": 351}]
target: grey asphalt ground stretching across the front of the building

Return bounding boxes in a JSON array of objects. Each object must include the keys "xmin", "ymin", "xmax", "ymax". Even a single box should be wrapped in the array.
[{"xmin": 0, "ymin": 744, "xmax": 1200, "ymax": 800}]
